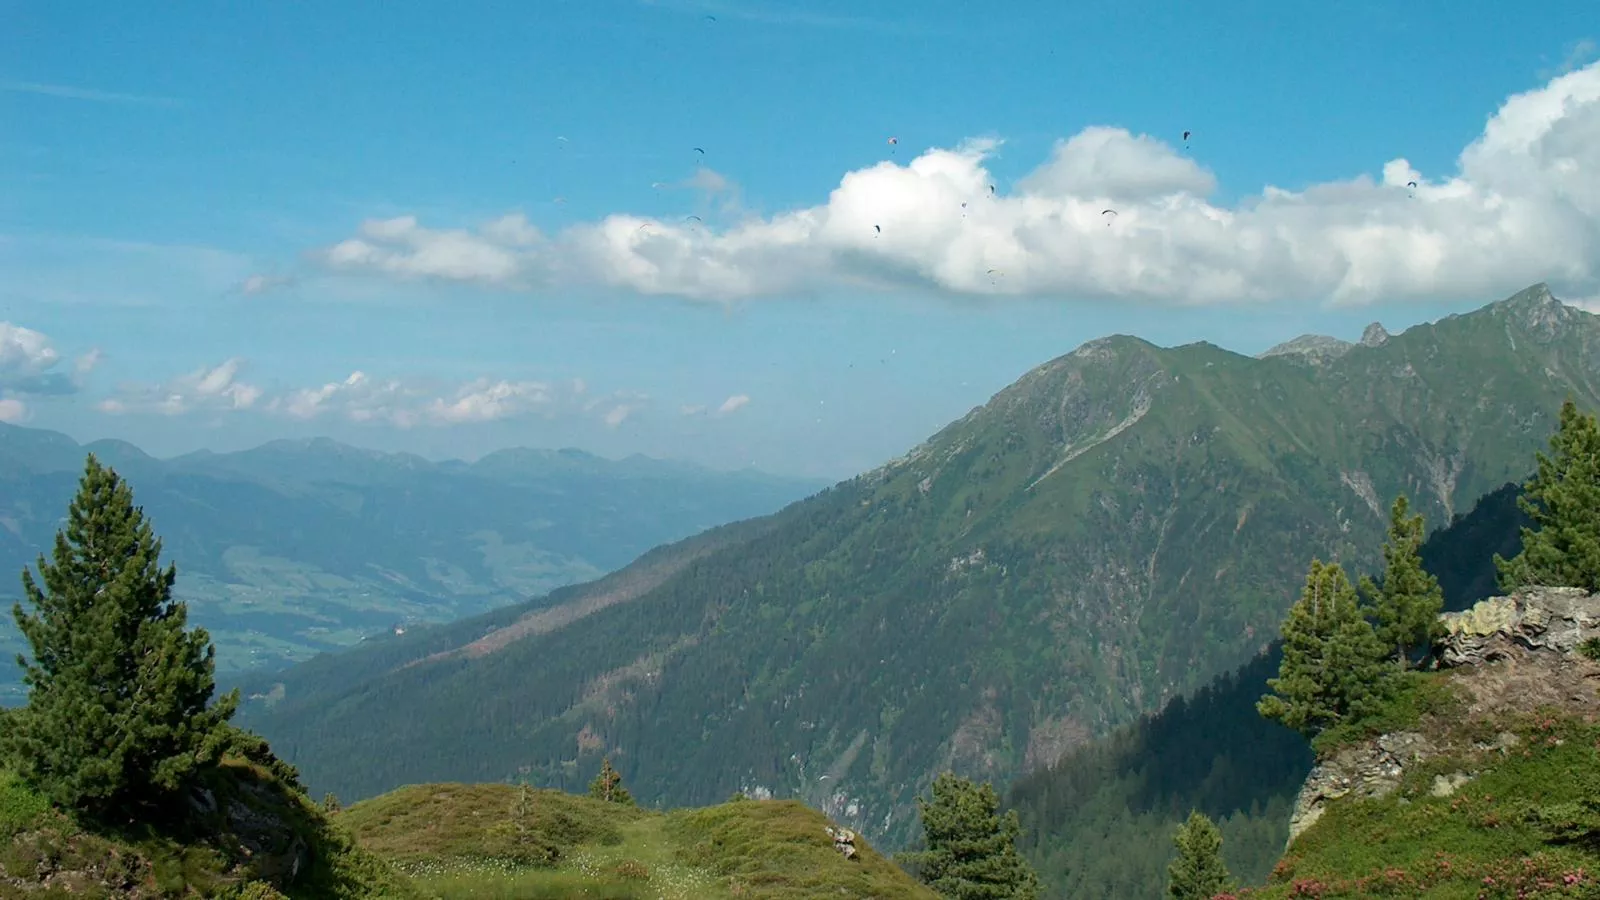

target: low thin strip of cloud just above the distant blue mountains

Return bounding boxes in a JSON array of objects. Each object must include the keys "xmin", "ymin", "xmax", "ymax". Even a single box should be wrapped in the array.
[{"xmin": 99, "ymin": 359, "xmax": 645, "ymax": 429}]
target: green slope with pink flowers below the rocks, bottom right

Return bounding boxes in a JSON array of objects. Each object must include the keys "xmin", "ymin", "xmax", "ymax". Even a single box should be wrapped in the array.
[{"xmin": 1240, "ymin": 713, "xmax": 1600, "ymax": 900}]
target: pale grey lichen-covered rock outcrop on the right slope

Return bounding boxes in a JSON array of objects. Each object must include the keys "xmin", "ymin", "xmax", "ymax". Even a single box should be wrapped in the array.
[{"xmin": 1290, "ymin": 588, "xmax": 1600, "ymax": 846}]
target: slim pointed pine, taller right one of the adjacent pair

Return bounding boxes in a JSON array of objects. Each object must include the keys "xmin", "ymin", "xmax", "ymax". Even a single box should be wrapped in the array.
[{"xmin": 1360, "ymin": 493, "xmax": 1445, "ymax": 669}]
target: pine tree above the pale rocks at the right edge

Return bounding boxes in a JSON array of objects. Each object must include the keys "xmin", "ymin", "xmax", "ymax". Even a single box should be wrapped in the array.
[{"xmin": 1494, "ymin": 397, "xmax": 1600, "ymax": 593}]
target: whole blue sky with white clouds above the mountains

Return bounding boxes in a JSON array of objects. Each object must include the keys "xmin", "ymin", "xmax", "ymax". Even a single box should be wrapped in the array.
[{"xmin": 0, "ymin": 0, "xmax": 1600, "ymax": 477}]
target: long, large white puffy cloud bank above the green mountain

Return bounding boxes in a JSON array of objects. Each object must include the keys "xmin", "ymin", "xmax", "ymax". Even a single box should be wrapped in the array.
[{"xmin": 305, "ymin": 62, "xmax": 1600, "ymax": 304}]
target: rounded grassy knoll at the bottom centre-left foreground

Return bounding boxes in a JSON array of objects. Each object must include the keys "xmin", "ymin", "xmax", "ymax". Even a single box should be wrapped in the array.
[{"xmin": 338, "ymin": 785, "xmax": 934, "ymax": 900}]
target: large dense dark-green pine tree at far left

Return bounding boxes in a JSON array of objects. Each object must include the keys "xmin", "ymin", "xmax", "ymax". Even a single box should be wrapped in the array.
[{"xmin": 0, "ymin": 455, "xmax": 238, "ymax": 817}]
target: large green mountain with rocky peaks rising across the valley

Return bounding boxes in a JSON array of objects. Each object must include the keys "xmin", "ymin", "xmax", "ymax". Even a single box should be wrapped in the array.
[{"xmin": 236, "ymin": 285, "xmax": 1600, "ymax": 844}]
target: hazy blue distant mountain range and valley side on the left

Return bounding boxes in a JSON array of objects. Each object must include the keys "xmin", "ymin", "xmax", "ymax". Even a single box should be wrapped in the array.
[{"xmin": 0, "ymin": 424, "xmax": 822, "ymax": 701}]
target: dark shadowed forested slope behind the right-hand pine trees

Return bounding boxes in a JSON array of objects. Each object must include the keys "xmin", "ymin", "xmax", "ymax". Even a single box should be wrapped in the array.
[{"xmin": 1006, "ymin": 474, "xmax": 1531, "ymax": 900}]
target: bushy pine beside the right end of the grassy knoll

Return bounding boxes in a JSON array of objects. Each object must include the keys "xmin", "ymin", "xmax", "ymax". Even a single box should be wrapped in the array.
[{"xmin": 904, "ymin": 772, "xmax": 1040, "ymax": 900}]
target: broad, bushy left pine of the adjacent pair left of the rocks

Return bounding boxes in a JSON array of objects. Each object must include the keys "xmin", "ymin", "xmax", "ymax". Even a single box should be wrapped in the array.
[{"xmin": 1256, "ymin": 559, "xmax": 1394, "ymax": 737}]
